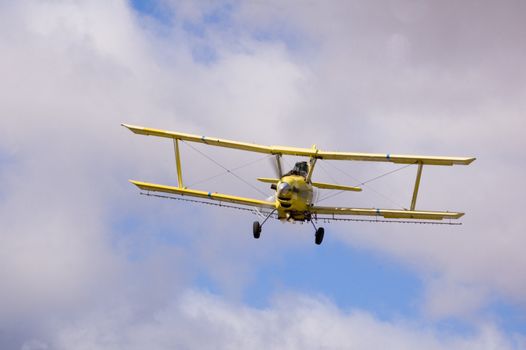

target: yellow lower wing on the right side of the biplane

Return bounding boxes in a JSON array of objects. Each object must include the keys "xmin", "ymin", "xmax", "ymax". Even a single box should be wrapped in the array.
[{"xmin": 311, "ymin": 207, "xmax": 464, "ymax": 220}]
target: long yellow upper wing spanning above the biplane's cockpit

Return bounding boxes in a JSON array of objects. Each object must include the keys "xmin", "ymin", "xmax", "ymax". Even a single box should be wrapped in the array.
[{"xmin": 122, "ymin": 124, "xmax": 475, "ymax": 165}]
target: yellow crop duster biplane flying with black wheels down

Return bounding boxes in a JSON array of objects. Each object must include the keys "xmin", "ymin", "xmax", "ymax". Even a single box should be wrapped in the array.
[{"xmin": 122, "ymin": 124, "xmax": 476, "ymax": 244}]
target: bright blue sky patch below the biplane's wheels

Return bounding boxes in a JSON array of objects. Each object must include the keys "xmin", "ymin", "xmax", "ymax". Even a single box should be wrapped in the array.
[{"xmin": 246, "ymin": 239, "xmax": 422, "ymax": 318}]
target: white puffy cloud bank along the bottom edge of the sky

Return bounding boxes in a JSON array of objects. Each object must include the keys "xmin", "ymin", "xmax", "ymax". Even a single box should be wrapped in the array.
[{"xmin": 43, "ymin": 291, "xmax": 525, "ymax": 349}]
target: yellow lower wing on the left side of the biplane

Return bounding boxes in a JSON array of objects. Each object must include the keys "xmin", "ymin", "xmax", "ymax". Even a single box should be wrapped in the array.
[{"xmin": 130, "ymin": 180, "xmax": 276, "ymax": 209}]
